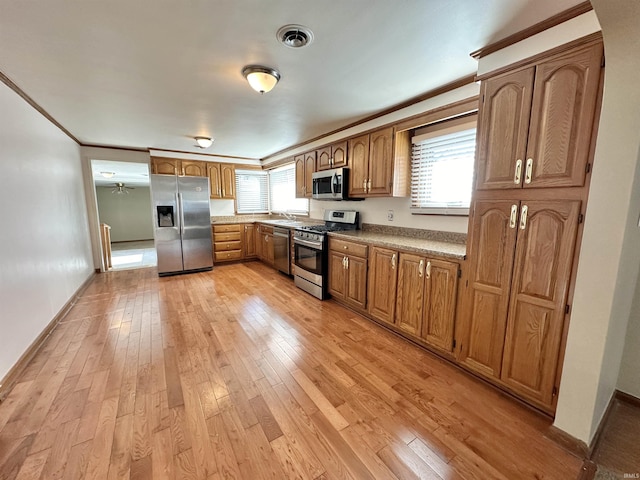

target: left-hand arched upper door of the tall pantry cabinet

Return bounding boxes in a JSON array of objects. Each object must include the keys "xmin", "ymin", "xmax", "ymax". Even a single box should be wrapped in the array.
[{"xmin": 476, "ymin": 67, "xmax": 534, "ymax": 190}]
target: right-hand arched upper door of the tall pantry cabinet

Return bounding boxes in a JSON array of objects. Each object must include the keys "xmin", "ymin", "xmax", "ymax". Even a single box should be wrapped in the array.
[{"xmin": 524, "ymin": 44, "xmax": 602, "ymax": 187}]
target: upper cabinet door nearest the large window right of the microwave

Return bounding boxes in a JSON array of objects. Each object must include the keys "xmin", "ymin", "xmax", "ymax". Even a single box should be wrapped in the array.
[{"xmin": 367, "ymin": 127, "xmax": 393, "ymax": 195}]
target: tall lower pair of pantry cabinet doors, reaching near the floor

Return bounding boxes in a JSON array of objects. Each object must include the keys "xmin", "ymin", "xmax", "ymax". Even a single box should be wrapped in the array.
[{"xmin": 459, "ymin": 199, "xmax": 581, "ymax": 408}]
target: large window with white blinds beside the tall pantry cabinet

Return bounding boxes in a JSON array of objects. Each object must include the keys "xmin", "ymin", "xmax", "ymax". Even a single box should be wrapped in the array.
[{"xmin": 411, "ymin": 115, "xmax": 476, "ymax": 215}]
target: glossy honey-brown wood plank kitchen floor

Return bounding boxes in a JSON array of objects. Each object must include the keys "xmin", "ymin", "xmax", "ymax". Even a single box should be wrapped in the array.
[{"xmin": 0, "ymin": 262, "xmax": 582, "ymax": 480}]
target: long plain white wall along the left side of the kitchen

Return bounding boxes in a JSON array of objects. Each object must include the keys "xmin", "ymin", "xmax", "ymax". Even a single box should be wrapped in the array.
[{"xmin": 0, "ymin": 83, "xmax": 93, "ymax": 379}]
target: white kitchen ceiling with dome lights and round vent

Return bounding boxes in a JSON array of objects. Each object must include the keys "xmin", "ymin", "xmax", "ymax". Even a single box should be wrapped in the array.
[{"xmin": 0, "ymin": 0, "xmax": 581, "ymax": 158}]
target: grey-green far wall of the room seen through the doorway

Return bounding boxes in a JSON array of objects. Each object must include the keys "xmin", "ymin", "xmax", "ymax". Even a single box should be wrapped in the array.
[{"xmin": 96, "ymin": 186, "xmax": 153, "ymax": 242}]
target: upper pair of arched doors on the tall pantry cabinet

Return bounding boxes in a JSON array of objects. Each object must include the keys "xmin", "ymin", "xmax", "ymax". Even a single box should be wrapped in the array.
[{"xmin": 476, "ymin": 42, "xmax": 603, "ymax": 190}]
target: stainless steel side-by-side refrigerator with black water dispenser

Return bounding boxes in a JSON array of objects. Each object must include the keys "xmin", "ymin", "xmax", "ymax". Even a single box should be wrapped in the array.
[{"xmin": 151, "ymin": 175, "xmax": 213, "ymax": 275}]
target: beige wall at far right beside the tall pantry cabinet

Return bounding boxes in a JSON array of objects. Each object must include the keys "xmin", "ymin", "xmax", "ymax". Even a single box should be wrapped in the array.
[{"xmin": 556, "ymin": 0, "xmax": 640, "ymax": 442}]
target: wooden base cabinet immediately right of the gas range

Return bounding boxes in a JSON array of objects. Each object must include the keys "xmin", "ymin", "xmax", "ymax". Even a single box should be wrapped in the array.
[{"xmin": 328, "ymin": 238, "xmax": 368, "ymax": 310}]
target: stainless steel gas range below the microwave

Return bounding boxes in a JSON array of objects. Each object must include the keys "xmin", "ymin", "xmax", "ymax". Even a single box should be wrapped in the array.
[{"xmin": 293, "ymin": 210, "xmax": 360, "ymax": 300}]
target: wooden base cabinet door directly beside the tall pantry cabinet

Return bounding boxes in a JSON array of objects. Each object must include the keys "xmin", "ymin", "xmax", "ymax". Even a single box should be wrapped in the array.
[{"xmin": 421, "ymin": 259, "xmax": 458, "ymax": 352}]
